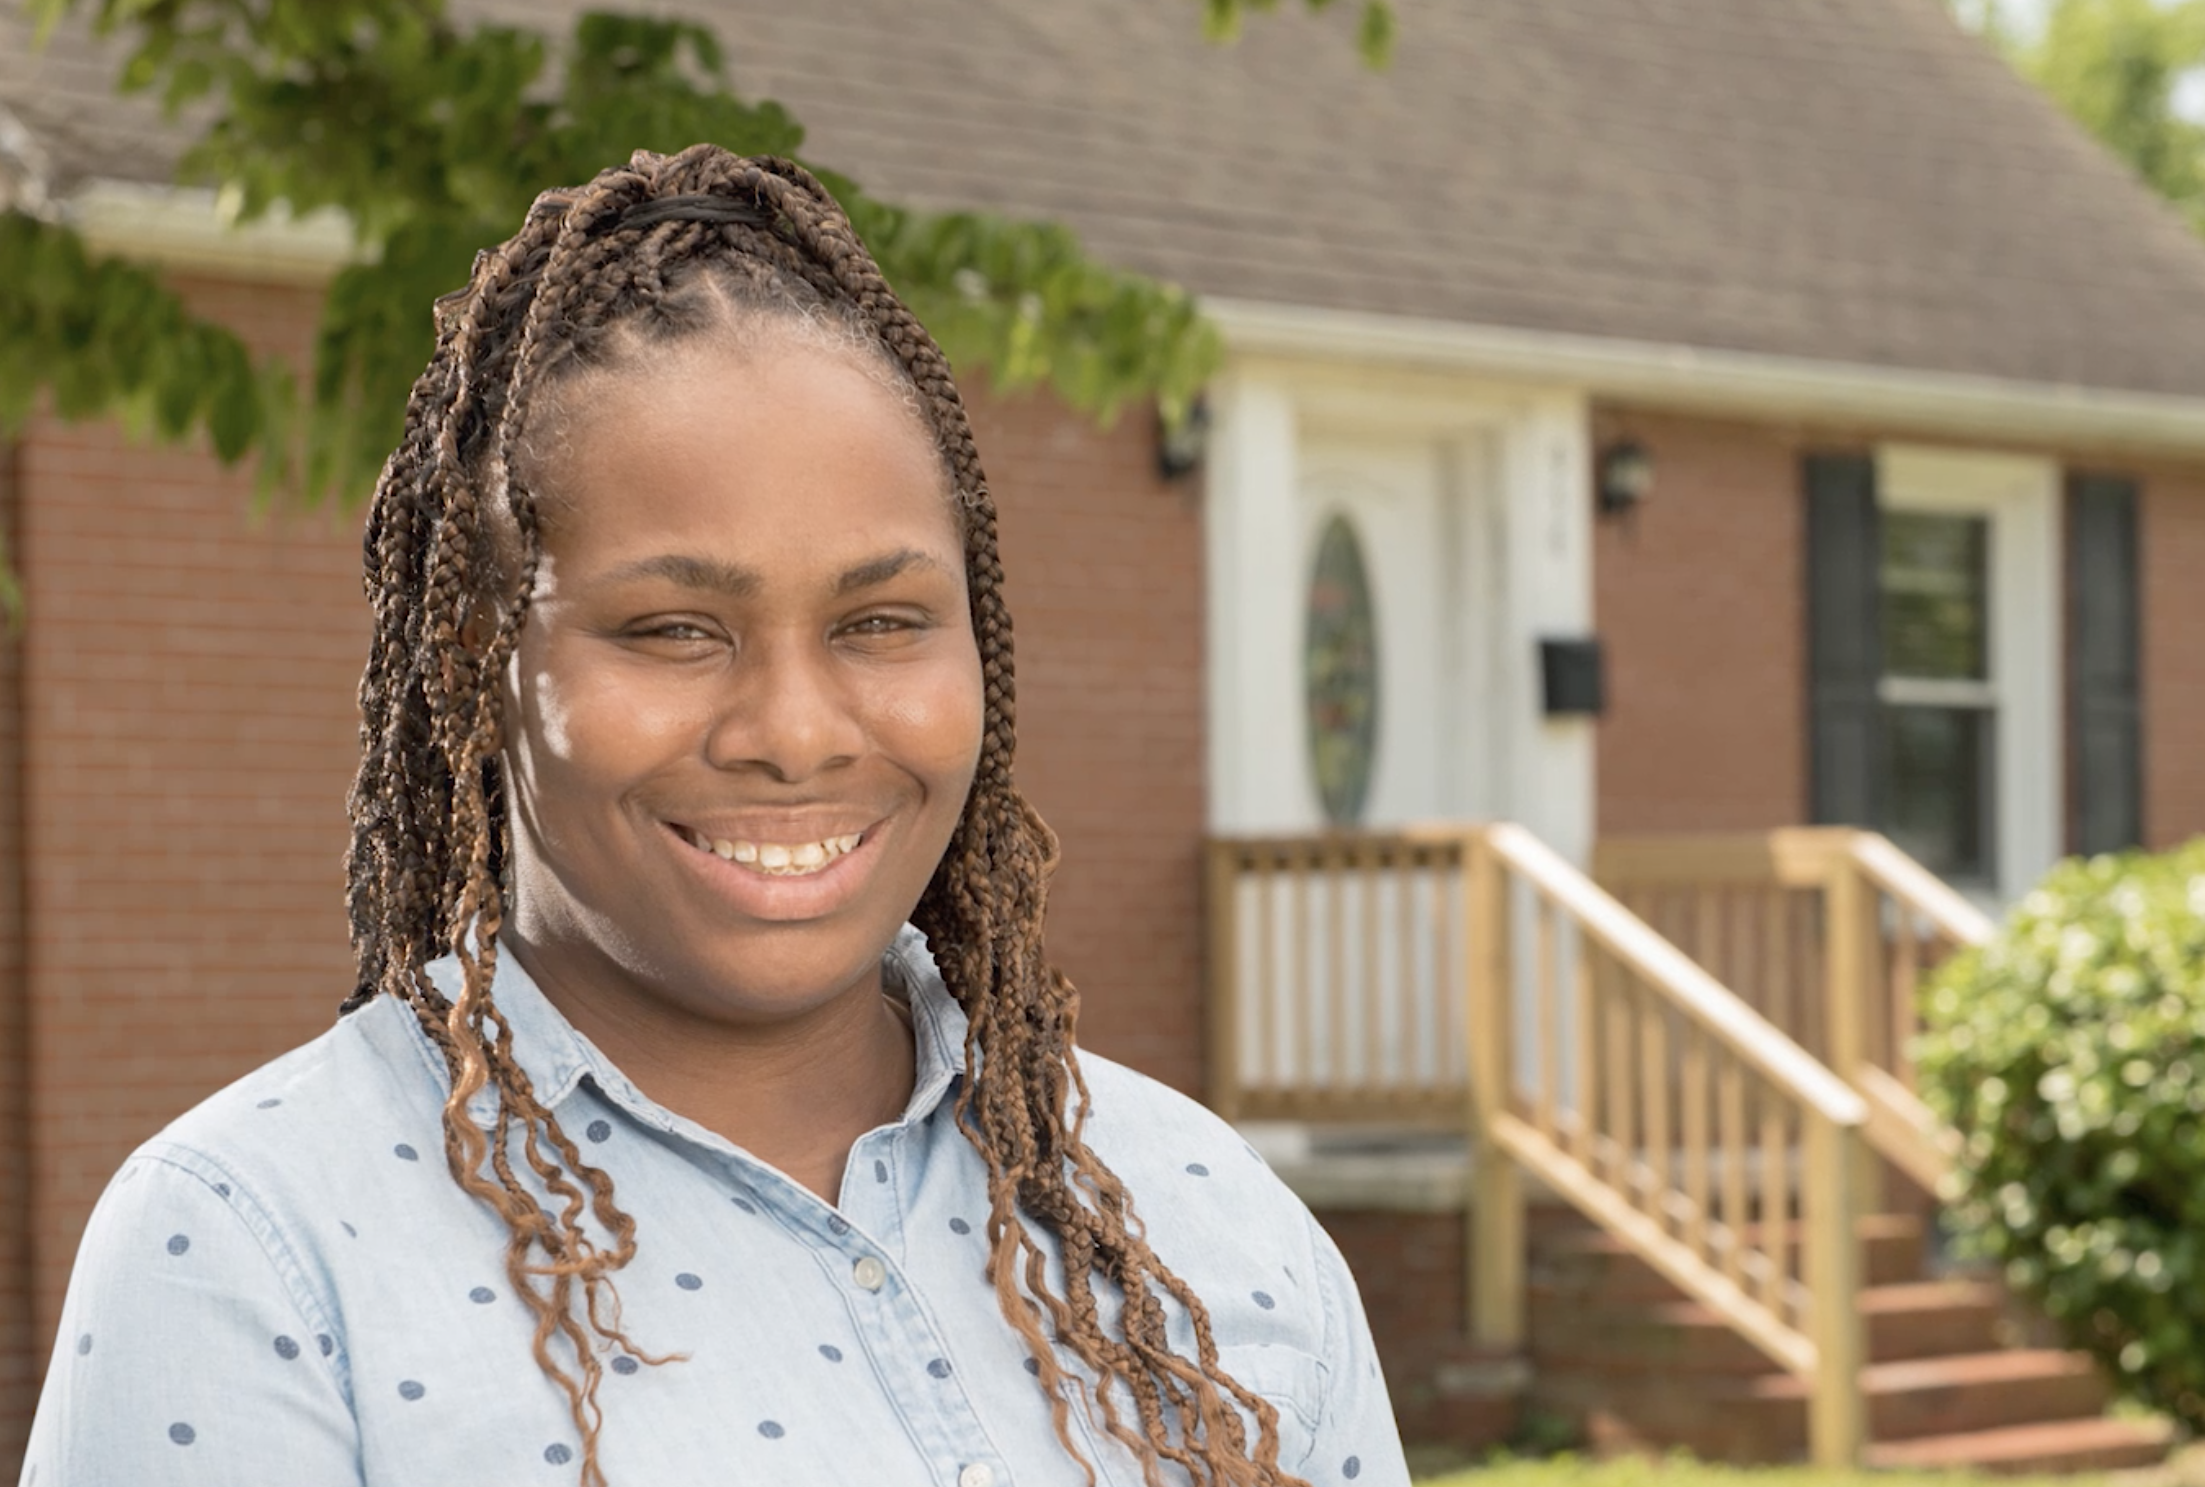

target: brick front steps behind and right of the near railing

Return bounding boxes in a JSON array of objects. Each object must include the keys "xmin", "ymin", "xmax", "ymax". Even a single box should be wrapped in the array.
[{"xmin": 1528, "ymin": 1213, "xmax": 2172, "ymax": 1472}]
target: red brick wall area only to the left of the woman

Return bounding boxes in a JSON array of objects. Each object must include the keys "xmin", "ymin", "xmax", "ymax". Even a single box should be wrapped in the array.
[{"xmin": 18, "ymin": 285, "xmax": 366, "ymax": 1411}]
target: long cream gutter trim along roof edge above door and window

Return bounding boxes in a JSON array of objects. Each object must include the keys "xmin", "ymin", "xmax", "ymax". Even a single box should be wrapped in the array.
[{"xmin": 1202, "ymin": 298, "xmax": 2205, "ymax": 452}]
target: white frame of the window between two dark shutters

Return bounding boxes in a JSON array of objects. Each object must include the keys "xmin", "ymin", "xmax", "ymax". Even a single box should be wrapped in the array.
[{"xmin": 1876, "ymin": 443, "xmax": 2066, "ymax": 902}]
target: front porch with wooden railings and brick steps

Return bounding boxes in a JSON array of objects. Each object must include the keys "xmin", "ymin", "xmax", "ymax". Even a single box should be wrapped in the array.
[{"xmin": 1206, "ymin": 825, "xmax": 2168, "ymax": 1467}]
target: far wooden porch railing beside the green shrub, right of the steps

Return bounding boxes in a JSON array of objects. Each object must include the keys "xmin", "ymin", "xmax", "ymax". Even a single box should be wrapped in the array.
[{"xmin": 1592, "ymin": 827, "xmax": 1991, "ymax": 1200}]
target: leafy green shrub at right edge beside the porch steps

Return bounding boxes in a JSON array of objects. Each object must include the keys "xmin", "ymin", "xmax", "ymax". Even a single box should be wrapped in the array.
[{"xmin": 1918, "ymin": 841, "xmax": 2205, "ymax": 1425}]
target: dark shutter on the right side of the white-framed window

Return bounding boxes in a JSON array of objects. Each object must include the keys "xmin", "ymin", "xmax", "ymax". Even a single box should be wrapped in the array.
[{"xmin": 2068, "ymin": 474, "xmax": 2143, "ymax": 852}]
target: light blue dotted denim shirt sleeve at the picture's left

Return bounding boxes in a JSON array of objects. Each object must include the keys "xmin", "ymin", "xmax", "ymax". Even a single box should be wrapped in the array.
[{"xmin": 22, "ymin": 1154, "xmax": 362, "ymax": 1487}]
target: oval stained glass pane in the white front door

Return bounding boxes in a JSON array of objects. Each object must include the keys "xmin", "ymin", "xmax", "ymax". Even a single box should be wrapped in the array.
[{"xmin": 1301, "ymin": 512, "xmax": 1378, "ymax": 825}]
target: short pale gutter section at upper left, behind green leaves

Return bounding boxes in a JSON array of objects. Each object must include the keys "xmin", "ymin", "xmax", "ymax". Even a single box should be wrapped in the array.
[{"xmin": 62, "ymin": 181, "xmax": 359, "ymax": 285}]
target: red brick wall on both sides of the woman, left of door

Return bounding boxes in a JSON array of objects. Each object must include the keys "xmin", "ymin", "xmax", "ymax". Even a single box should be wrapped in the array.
[{"xmin": 0, "ymin": 282, "xmax": 1202, "ymax": 1474}]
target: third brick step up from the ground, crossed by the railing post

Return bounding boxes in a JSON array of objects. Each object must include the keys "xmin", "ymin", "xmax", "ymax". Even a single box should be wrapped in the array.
[{"xmin": 1528, "ymin": 1280, "xmax": 2004, "ymax": 1374}]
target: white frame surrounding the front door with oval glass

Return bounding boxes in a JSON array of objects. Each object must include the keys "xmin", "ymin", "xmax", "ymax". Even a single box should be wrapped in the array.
[{"xmin": 1204, "ymin": 357, "xmax": 1594, "ymax": 863}]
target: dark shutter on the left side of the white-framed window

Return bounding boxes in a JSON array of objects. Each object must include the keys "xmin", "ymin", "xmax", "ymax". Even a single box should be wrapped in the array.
[{"xmin": 1806, "ymin": 454, "xmax": 1883, "ymax": 825}]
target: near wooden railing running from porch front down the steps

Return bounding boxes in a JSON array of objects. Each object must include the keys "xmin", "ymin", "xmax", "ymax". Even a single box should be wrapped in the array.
[{"xmin": 1208, "ymin": 825, "xmax": 1870, "ymax": 1465}]
